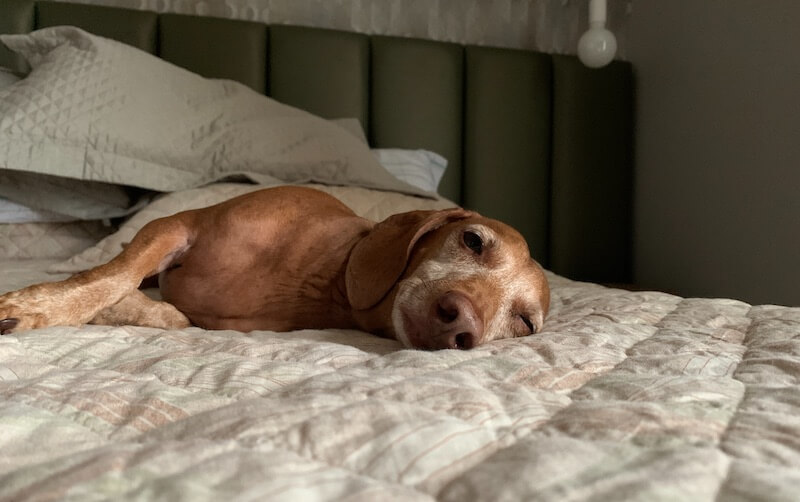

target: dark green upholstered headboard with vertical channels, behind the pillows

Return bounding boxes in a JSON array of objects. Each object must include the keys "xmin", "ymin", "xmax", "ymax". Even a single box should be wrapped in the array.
[{"xmin": 0, "ymin": 0, "xmax": 633, "ymax": 282}]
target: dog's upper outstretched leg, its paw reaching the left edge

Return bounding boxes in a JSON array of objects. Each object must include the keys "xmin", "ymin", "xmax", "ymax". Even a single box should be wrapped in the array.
[{"xmin": 0, "ymin": 213, "xmax": 192, "ymax": 334}]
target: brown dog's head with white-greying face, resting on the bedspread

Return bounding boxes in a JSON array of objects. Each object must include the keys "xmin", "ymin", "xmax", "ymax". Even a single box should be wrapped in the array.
[{"xmin": 346, "ymin": 209, "xmax": 550, "ymax": 350}]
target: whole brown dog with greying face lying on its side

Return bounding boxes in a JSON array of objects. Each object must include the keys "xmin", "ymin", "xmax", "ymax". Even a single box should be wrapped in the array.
[{"xmin": 0, "ymin": 187, "xmax": 550, "ymax": 349}]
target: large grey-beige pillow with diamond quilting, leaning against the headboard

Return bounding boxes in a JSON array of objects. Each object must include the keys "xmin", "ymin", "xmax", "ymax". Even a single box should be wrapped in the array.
[{"xmin": 0, "ymin": 26, "xmax": 430, "ymax": 204}]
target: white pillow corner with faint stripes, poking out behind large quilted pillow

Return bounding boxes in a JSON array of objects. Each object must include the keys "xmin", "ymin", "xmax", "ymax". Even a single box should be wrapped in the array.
[{"xmin": 372, "ymin": 148, "xmax": 447, "ymax": 193}]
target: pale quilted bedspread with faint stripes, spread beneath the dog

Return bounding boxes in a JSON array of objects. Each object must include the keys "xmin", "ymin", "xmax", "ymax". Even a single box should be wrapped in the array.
[{"xmin": 0, "ymin": 268, "xmax": 800, "ymax": 501}]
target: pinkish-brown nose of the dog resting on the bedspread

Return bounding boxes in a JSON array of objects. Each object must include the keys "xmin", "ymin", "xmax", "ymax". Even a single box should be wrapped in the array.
[{"xmin": 432, "ymin": 291, "xmax": 483, "ymax": 350}]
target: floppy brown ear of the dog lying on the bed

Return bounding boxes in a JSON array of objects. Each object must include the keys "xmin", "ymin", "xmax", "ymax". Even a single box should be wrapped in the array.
[{"xmin": 345, "ymin": 208, "xmax": 475, "ymax": 310}]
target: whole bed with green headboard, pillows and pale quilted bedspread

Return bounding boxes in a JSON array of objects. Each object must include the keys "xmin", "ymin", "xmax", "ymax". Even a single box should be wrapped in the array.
[{"xmin": 0, "ymin": 0, "xmax": 800, "ymax": 501}]
